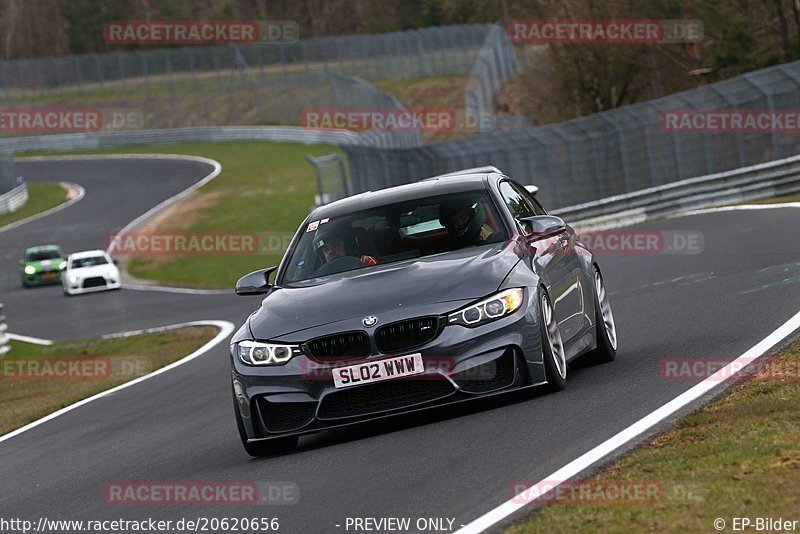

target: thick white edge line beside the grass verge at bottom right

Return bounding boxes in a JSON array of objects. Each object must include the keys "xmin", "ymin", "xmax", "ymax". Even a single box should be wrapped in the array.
[{"xmin": 456, "ymin": 312, "xmax": 800, "ymax": 534}]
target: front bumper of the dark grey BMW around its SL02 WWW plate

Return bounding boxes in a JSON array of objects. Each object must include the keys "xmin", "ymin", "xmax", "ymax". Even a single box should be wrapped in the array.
[{"xmin": 231, "ymin": 310, "xmax": 545, "ymax": 440}]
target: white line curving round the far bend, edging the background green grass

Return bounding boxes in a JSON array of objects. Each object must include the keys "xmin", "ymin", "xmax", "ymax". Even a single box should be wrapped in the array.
[{"xmin": 17, "ymin": 154, "xmax": 223, "ymax": 295}]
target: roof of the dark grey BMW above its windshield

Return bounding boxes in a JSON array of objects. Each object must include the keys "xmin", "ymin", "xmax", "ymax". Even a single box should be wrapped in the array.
[{"xmin": 313, "ymin": 167, "xmax": 501, "ymax": 218}]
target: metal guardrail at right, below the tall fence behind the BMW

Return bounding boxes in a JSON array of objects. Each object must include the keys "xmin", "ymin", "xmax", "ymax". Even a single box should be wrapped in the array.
[{"xmin": 552, "ymin": 156, "xmax": 800, "ymax": 230}]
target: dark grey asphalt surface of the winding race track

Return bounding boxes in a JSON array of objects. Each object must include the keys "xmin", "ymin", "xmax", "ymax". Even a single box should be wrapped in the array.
[{"xmin": 0, "ymin": 160, "xmax": 800, "ymax": 532}]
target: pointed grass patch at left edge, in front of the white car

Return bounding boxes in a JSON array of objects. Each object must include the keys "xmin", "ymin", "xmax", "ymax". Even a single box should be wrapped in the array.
[{"xmin": 0, "ymin": 326, "xmax": 217, "ymax": 435}]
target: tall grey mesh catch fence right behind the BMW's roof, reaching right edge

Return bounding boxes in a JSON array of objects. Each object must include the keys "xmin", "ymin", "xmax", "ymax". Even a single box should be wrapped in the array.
[{"xmin": 344, "ymin": 58, "xmax": 800, "ymax": 208}]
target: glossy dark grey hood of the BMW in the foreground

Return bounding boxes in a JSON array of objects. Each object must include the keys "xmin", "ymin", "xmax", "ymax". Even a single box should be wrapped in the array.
[{"xmin": 249, "ymin": 243, "xmax": 519, "ymax": 339}]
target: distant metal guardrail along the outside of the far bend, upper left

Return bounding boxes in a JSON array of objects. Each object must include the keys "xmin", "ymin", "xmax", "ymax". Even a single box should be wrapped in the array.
[{"xmin": 0, "ymin": 126, "xmax": 360, "ymax": 152}]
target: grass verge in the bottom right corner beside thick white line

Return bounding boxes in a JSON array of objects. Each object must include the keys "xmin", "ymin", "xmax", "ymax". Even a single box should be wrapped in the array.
[{"xmin": 508, "ymin": 342, "xmax": 800, "ymax": 534}]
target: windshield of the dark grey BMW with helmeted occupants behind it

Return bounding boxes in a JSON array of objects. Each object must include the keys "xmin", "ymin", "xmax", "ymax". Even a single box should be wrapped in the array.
[{"xmin": 283, "ymin": 191, "xmax": 507, "ymax": 284}]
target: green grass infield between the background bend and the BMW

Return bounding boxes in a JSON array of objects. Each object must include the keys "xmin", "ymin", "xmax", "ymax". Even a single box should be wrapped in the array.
[{"xmin": 22, "ymin": 141, "xmax": 343, "ymax": 288}]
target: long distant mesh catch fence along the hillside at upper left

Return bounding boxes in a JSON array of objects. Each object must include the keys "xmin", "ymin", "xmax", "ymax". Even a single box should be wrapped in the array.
[{"xmin": 0, "ymin": 24, "xmax": 500, "ymax": 134}]
